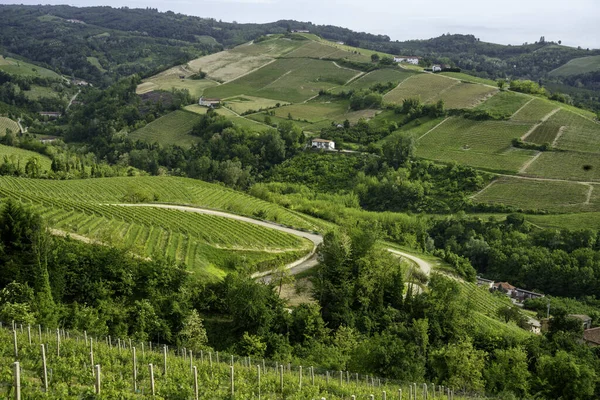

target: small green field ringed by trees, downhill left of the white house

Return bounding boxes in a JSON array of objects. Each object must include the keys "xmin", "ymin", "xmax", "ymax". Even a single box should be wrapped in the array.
[{"xmin": 129, "ymin": 110, "xmax": 200, "ymax": 147}]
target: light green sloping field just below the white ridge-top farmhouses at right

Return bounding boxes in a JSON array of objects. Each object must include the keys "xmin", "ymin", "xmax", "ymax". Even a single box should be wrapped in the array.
[{"xmin": 383, "ymin": 74, "xmax": 460, "ymax": 104}]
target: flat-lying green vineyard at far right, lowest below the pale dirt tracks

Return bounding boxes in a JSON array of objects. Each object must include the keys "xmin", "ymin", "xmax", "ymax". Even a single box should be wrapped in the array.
[{"xmin": 474, "ymin": 178, "xmax": 600, "ymax": 213}]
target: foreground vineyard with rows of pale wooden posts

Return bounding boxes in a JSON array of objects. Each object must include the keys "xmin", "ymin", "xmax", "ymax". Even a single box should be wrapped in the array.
[{"xmin": 0, "ymin": 324, "xmax": 478, "ymax": 400}]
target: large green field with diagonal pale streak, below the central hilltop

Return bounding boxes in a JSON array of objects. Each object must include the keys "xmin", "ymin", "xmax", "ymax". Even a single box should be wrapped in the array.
[{"xmin": 205, "ymin": 59, "xmax": 359, "ymax": 103}]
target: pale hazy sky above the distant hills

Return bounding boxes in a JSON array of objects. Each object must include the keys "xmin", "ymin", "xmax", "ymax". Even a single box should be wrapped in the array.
[{"xmin": 0, "ymin": 0, "xmax": 600, "ymax": 48}]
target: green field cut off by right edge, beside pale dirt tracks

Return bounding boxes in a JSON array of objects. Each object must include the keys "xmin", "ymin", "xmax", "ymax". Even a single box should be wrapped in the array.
[{"xmin": 548, "ymin": 110, "xmax": 600, "ymax": 153}]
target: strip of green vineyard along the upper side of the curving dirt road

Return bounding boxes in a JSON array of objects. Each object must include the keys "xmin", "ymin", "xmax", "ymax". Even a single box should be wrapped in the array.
[{"xmin": 0, "ymin": 176, "xmax": 325, "ymax": 231}]
